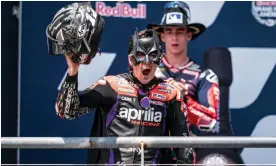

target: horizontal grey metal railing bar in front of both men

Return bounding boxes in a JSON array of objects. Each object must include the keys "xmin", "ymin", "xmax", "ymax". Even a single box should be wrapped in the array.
[{"xmin": 1, "ymin": 137, "xmax": 276, "ymax": 149}]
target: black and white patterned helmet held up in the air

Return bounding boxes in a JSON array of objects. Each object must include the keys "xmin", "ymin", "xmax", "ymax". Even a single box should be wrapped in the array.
[{"xmin": 46, "ymin": 2, "xmax": 104, "ymax": 64}]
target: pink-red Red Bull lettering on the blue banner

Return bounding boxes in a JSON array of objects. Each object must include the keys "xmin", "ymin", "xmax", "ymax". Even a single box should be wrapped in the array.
[{"xmin": 96, "ymin": 2, "xmax": 147, "ymax": 19}]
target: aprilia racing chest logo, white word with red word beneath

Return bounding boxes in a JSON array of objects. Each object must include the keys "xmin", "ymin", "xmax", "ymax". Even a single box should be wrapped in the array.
[{"xmin": 119, "ymin": 107, "xmax": 162, "ymax": 126}]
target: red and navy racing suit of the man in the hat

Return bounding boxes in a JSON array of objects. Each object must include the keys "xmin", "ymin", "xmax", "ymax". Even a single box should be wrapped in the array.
[{"xmin": 155, "ymin": 56, "xmax": 222, "ymax": 162}]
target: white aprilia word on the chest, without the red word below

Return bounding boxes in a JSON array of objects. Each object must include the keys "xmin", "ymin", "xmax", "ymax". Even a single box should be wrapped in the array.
[{"xmin": 119, "ymin": 107, "xmax": 162, "ymax": 122}]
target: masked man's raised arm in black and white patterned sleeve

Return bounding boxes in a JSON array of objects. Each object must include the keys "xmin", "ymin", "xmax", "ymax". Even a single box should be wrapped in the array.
[{"xmin": 55, "ymin": 74, "xmax": 116, "ymax": 119}]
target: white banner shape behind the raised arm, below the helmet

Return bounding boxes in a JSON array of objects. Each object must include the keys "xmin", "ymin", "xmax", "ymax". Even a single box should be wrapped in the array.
[{"xmin": 58, "ymin": 52, "xmax": 116, "ymax": 91}]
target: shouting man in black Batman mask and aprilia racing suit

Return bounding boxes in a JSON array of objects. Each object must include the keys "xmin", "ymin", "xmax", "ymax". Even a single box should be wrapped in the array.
[{"xmin": 52, "ymin": 3, "xmax": 192, "ymax": 165}]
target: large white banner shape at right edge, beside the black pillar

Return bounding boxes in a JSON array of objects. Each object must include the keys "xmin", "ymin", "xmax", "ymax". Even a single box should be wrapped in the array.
[{"xmin": 229, "ymin": 47, "xmax": 276, "ymax": 109}]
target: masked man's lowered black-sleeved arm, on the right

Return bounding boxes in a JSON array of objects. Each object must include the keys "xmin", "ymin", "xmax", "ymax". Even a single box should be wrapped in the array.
[{"xmin": 167, "ymin": 94, "xmax": 189, "ymax": 163}]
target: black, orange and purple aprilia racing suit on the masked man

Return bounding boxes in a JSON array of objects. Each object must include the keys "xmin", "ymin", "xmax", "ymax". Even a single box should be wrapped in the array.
[{"xmin": 56, "ymin": 73, "xmax": 189, "ymax": 164}]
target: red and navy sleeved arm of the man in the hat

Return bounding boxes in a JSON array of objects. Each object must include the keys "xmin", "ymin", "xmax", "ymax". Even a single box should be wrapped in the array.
[{"xmin": 187, "ymin": 69, "xmax": 220, "ymax": 130}]
